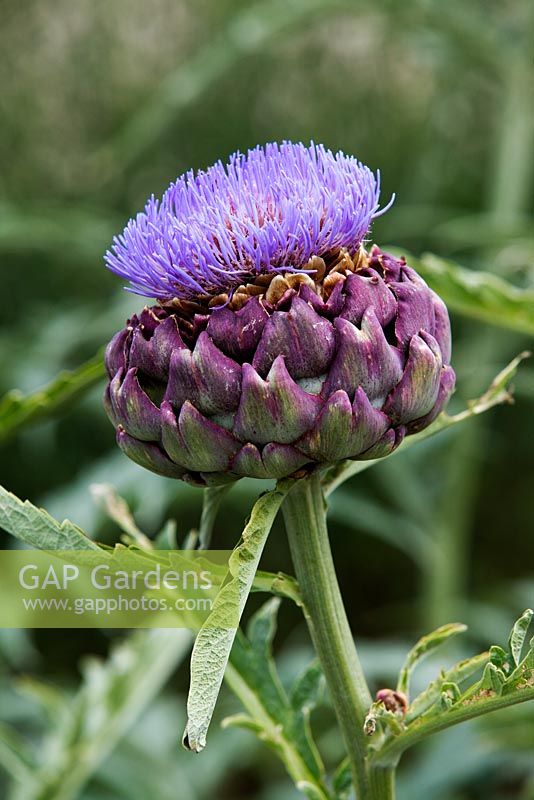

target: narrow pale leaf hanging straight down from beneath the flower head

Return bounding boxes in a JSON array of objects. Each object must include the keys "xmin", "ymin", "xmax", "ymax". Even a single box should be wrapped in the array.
[{"xmin": 183, "ymin": 484, "xmax": 289, "ymax": 752}]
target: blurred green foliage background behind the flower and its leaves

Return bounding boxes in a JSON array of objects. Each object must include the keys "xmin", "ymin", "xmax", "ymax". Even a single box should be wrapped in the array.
[{"xmin": 0, "ymin": 0, "xmax": 534, "ymax": 800}]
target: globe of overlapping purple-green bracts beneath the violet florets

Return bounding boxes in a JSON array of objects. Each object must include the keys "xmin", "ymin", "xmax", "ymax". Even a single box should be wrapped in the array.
[{"xmin": 106, "ymin": 248, "xmax": 454, "ymax": 484}]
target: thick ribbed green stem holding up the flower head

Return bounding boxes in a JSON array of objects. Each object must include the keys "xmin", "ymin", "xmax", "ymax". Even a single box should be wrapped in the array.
[{"xmin": 282, "ymin": 474, "xmax": 394, "ymax": 800}]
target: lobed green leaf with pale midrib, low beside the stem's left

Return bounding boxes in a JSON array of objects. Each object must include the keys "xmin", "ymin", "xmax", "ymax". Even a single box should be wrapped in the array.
[{"xmin": 224, "ymin": 598, "xmax": 330, "ymax": 800}]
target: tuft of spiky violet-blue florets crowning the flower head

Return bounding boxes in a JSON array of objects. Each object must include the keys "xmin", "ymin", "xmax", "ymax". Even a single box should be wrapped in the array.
[{"xmin": 106, "ymin": 142, "xmax": 392, "ymax": 301}]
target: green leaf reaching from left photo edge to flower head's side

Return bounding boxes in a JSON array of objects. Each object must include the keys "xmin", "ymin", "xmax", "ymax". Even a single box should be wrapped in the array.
[{"xmin": 0, "ymin": 353, "xmax": 105, "ymax": 442}]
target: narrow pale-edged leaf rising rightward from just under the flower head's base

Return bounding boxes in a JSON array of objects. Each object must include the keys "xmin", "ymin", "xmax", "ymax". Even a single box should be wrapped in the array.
[{"xmin": 323, "ymin": 352, "xmax": 530, "ymax": 495}]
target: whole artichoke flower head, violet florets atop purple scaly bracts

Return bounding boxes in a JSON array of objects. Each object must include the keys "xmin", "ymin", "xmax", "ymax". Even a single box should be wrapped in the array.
[{"xmin": 106, "ymin": 142, "xmax": 454, "ymax": 484}]
